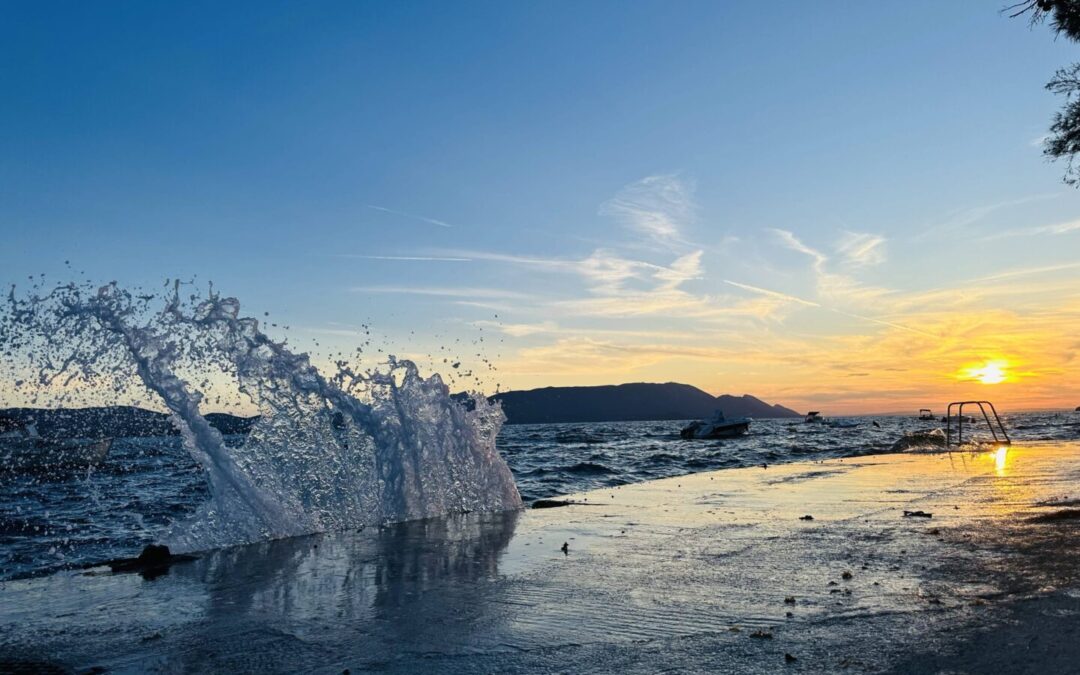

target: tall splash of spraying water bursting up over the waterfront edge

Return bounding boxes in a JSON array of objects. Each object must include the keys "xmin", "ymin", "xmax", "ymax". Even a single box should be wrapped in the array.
[{"xmin": 0, "ymin": 283, "xmax": 522, "ymax": 551}]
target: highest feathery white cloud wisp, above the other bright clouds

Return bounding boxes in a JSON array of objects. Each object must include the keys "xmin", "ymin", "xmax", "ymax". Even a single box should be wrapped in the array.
[{"xmin": 600, "ymin": 174, "xmax": 698, "ymax": 244}]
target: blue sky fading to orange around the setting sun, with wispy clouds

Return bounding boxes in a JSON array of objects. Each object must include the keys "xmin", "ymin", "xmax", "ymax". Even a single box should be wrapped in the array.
[{"xmin": 0, "ymin": 0, "xmax": 1080, "ymax": 415}]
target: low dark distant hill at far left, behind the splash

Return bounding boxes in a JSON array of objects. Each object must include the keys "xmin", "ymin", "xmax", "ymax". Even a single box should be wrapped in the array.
[{"xmin": 0, "ymin": 406, "xmax": 258, "ymax": 438}]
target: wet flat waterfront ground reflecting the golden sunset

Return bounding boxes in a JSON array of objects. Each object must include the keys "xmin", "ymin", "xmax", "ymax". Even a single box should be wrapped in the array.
[{"xmin": 0, "ymin": 444, "xmax": 1080, "ymax": 673}]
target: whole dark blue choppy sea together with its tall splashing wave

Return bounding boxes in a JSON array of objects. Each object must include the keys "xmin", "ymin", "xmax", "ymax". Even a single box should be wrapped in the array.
[{"xmin": 0, "ymin": 284, "xmax": 1080, "ymax": 580}]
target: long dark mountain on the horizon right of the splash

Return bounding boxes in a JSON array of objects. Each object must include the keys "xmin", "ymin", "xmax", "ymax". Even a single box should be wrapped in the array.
[{"xmin": 491, "ymin": 382, "xmax": 801, "ymax": 424}]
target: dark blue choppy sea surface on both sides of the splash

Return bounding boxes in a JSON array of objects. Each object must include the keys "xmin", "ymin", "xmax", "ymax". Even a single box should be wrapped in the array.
[{"xmin": 0, "ymin": 413, "xmax": 1080, "ymax": 579}]
